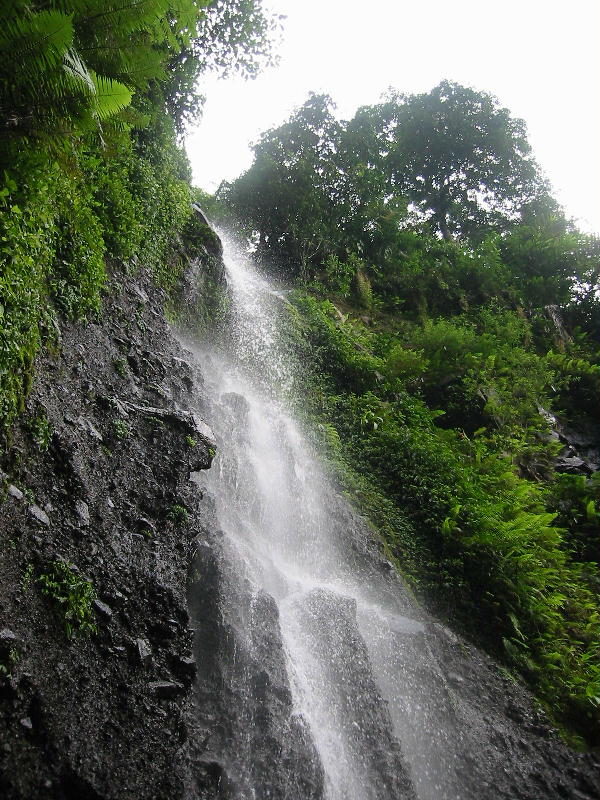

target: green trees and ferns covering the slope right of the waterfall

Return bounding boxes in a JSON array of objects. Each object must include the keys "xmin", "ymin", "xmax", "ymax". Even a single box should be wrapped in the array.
[{"xmin": 219, "ymin": 87, "xmax": 600, "ymax": 741}]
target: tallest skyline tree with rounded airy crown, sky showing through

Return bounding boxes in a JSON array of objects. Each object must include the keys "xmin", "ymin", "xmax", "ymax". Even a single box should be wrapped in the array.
[{"xmin": 382, "ymin": 81, "xmax": 546, "ymax": 244}]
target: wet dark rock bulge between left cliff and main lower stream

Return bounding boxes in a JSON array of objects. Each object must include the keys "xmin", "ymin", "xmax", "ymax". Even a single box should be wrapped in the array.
[{"xmin": 189, "ymin": 532, "xmax": 324, "ymax": 800}]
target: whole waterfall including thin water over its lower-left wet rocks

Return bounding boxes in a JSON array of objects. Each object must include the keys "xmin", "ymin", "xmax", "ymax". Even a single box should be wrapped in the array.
[{"xmin": 187, "ymin": 231, "xmax": 576, "ymax": 800}]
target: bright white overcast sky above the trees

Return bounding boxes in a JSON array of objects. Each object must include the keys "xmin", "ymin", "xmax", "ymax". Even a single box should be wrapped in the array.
[{"xmin": 187, "ymin": 0, "xmax": 600, "ymax": 232}]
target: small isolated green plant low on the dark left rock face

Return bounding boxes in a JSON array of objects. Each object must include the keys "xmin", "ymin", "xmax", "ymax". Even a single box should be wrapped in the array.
[{"xmin": 37, "ymin": 561, "xmax": 97, "ymax": 639}]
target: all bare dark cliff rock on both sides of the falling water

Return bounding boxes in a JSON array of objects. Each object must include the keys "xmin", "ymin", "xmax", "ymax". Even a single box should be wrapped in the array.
[{"xmin": 0, "ymin": 222, "xmax": 597, "ymax": 800}]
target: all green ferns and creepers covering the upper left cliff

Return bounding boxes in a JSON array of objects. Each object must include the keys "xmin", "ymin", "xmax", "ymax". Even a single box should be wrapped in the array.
[{"xmin": 0, "ymin": 0, "xmax": 273, "ymax": 439}]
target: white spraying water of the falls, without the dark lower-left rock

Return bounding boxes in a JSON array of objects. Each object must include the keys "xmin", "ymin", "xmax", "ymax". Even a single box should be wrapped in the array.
[{"xmin": 185, "ymin": 231, "xmax": 476, "ymax": 800}]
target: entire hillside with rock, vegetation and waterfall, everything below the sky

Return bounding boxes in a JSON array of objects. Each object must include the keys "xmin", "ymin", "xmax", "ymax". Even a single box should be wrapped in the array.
[{"xmin": 0, "ymin": 0, "xmax": 600, "ymax": 800}]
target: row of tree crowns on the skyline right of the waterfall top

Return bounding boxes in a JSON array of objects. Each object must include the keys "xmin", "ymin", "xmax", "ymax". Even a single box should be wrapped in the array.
[{"xmin": 219, "ymin": 81, "xmax": 593, "ymax": 312}]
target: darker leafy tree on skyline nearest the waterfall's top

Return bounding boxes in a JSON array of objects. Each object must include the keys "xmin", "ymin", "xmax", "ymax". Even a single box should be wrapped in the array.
[{"xmin": 220, "ymin": 94, "xmax": 406, "ymax": 276}]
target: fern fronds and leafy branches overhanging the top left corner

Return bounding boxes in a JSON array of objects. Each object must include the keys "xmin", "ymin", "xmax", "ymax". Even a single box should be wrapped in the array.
[{"xmin": 0, "ymin": 0, "xmax": 275, "ymax": 143}]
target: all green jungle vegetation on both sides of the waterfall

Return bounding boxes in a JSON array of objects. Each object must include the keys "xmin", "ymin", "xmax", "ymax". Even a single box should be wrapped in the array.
[{"xmin": 0, "ymin": 0, "xmax": 600, "ymax": 752}]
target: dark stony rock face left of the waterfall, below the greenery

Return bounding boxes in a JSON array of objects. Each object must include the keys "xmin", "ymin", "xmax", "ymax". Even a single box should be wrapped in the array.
[{"xmin": 0, "ymin": 260, "xmax": 214, "ymax": 800}]
